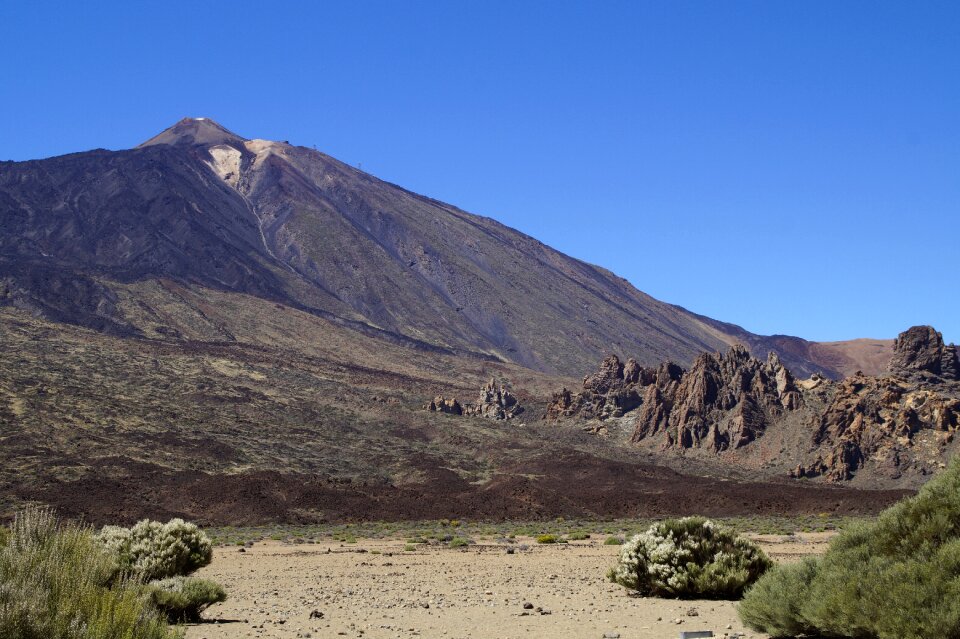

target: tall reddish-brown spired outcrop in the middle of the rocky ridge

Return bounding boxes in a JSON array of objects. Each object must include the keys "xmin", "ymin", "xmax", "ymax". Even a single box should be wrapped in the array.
[{"xmin": 633, "ymin": 345, "xmax": 802, "ymax": 452}]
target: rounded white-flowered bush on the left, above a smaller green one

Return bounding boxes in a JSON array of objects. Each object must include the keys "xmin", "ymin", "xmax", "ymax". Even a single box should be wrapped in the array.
[{"xmin": 97, "ymin": 519, "xmax": 213, "ymax": 581}]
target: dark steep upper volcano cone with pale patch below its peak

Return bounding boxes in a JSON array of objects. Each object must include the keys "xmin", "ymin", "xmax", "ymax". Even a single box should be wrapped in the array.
[{"xmin": 0, "ymin": 118, "xmax": 872, "ymax": 377}]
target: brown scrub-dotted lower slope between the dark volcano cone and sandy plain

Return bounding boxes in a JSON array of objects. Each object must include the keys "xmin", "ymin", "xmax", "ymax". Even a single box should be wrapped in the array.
[{"xmin": 0, "ymin": 308, "xmax": 904, "ymax": 524}]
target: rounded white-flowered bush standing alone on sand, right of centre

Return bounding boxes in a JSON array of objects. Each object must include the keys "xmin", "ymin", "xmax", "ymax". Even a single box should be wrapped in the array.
[{"xmin": 607, "ymin": 517, "xmax": 771, "ymax": 599}]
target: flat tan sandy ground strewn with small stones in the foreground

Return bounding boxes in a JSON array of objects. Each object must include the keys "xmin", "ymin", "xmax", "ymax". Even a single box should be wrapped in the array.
[{"xmin": 187, "ymin": 534, "xmax": 829, "ymax": 639}]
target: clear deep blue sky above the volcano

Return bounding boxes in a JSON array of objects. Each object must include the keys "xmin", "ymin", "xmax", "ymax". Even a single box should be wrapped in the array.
[{"xmin": 0, "ymin": 0, "xmax": 960, "ymax": 341}]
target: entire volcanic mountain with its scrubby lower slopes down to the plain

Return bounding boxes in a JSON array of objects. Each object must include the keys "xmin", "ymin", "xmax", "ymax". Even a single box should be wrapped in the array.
[{"xmin": 0, "ymin": 118, "xmax": 926, "ymax": 524}]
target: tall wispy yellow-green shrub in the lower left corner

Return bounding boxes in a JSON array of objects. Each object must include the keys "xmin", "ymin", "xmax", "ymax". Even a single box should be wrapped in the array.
[{"xmin": 0, "ymin": 509, "xmax": 181, "ymax": 639}]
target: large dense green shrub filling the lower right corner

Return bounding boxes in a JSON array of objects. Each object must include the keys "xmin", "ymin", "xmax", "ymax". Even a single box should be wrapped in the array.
[{"xmin": 740, "ymin": 459, "xmax": 960, "ymax": 639}]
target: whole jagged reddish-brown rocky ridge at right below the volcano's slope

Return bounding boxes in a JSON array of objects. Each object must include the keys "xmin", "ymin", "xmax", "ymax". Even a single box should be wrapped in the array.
[{"xmin": 546, "ymin": 326, "xmax": 960, "ymax": 482}]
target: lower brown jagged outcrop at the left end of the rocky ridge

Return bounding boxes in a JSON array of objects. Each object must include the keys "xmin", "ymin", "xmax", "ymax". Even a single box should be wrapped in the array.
[{"xmin": 547, "ymin": 355, "xmax": 683, "ymax": 420}]
